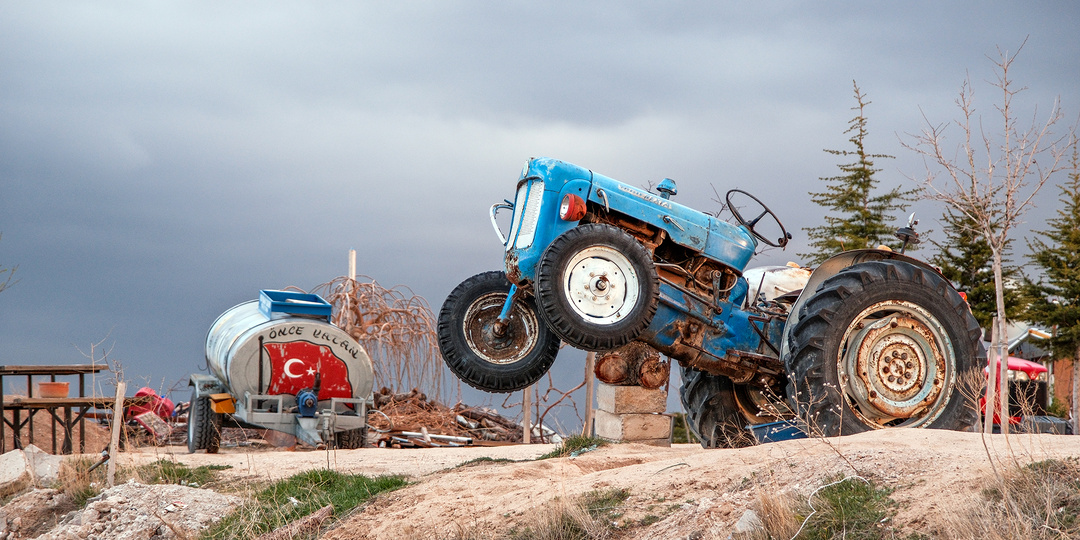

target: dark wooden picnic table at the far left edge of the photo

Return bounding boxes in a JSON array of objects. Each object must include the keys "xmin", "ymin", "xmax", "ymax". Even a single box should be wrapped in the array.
[{"xmin": 0, "ymin": 364, "xmax": 149, "ymax": 454}]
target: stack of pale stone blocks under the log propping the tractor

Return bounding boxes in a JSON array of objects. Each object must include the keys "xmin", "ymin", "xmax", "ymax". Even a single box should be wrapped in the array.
[{"xmin": 593, "ymin": 382, "xmax": 672, "ymax": 446}]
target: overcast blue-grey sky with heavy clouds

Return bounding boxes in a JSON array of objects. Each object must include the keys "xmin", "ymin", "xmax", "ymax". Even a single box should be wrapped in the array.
[{"xmin": 0, "ymin": 1, "xmax": 1080, "ymax": 421}]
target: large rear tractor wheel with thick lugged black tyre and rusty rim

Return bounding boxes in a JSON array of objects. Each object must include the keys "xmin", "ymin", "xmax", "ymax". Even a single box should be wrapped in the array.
[{"xmin": 785, "ymin": 260, "xmax": 986, "ymax": 436}]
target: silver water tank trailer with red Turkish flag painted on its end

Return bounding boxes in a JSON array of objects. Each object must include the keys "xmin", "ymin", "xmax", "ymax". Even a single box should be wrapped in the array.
[{"xmin": 188, "ymin": 291, "xmax": 374, "ymax": 454}]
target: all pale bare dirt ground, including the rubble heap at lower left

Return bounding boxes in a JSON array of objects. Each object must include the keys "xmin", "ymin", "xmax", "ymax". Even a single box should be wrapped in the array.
[{"xmin": 0, "ymin": 406, "xmax": 1080, "ymax": 540}]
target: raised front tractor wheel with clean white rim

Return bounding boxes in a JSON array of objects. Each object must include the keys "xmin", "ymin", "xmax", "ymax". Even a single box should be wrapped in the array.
[{"xmin": 536, "ymin": 224, "xmax": 660, "ymax": 351}]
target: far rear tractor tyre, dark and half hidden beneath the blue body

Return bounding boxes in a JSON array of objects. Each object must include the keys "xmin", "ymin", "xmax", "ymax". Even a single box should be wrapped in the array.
[{"xmin": 678, "ymin": 366, "xmax": 754, "ymax": 448}]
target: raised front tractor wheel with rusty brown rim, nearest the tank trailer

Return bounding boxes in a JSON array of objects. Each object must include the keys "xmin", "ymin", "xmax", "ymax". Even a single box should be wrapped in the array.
[{"xmin": 438, "ymin": 272, "xmax": 558, "ymax": 392}]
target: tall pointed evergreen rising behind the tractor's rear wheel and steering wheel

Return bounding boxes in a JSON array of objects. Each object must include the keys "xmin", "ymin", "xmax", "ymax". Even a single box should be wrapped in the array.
[{"xmin": 799, "ymin": 81, "xmax": 915, "ymax": 265}]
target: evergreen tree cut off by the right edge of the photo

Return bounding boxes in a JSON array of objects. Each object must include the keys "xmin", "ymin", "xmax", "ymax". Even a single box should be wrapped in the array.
[{"xmin": 1027, "ymin": 139, "xmax": 1080, "ymax": 433}]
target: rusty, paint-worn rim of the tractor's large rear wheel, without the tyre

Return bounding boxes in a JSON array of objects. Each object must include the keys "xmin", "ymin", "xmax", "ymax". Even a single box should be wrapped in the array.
[{"xmin": 837, "ymin": 300, "xmax": 956, "ymax": 428}]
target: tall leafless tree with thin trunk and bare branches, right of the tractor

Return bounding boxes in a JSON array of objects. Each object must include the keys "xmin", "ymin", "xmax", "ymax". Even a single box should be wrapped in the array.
[{"xmin": 902, "ymin": 40, "xmax": 1067, "ymax": 432}]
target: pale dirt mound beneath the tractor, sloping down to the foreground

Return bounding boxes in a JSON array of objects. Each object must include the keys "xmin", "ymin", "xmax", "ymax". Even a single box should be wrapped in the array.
[{"xmin": 323, "ymin": 430, "xmax": 1080, "ymax": 540}]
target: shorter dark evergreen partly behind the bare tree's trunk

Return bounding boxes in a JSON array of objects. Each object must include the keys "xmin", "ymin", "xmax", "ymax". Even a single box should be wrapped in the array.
[{"xmin": 930, "ymin": 207, "xmax": 1024, "ymax": 328}]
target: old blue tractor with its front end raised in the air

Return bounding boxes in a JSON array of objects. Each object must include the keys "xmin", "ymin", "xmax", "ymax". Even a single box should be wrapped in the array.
[{"xmin": 438, "ymin": 158, "xmax": 985, "ymax": 447}]
